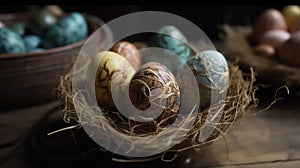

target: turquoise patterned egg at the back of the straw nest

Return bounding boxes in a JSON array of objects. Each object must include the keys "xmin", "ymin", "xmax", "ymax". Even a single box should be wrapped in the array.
[{"xmin": 154, "ymin": 25, "xmax": 193, "ymax": 62}]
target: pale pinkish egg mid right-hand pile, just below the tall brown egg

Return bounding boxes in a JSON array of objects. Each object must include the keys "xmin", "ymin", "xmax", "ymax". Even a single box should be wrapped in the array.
[{"xmin": 259, "ymin": 30, "xmax": 291, "ymax": 50}]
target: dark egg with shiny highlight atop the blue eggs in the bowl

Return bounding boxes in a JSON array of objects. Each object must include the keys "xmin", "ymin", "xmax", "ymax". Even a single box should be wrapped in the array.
[{"xmin": 28, "ymin": 9, "xmax": 57, "ymax": 35}]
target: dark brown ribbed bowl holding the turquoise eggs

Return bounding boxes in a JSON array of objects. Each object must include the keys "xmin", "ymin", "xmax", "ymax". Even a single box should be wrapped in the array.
[{"xmin": 0, "ymin": 12, "xmax": 107, "ymax": 108}]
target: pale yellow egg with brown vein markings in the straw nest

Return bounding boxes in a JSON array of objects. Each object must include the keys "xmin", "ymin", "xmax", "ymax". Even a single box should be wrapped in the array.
[{"xmin": 92, "ymin": 51, "xmax": 135, "ymax": 110}]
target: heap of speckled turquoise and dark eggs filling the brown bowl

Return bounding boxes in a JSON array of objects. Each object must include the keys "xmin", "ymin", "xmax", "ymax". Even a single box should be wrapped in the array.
[{"xmin": 0, "ymin": 5, "xmax": 88, "ymax": 54}]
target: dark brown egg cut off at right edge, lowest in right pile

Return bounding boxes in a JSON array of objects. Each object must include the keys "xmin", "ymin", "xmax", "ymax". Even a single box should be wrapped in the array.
[{"xmin": 278, "ymin": 31, "xmax": 300, "ymax": 66}]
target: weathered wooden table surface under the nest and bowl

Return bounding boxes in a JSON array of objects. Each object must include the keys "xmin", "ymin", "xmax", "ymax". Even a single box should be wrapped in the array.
[{"xmin": 0, "ymin": 93, "xmax": 300, "ymax": 168}]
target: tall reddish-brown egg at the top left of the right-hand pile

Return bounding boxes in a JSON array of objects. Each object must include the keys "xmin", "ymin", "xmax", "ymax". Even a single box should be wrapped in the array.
[{"xmin": 252, "ymin": 9, "xmax": 287, "ymax": 42}]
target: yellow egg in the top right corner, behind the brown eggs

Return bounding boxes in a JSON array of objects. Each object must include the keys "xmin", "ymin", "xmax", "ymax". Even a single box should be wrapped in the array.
[{"xmin": 282, "ymin": 5, "xmax": 300, "ymax": 32}]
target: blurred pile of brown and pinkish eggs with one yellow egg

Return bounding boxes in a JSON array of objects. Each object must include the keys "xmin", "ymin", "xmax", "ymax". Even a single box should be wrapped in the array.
[{"xmin": 251, "ymin": 5, "xmax": 300, "ymax": 66}]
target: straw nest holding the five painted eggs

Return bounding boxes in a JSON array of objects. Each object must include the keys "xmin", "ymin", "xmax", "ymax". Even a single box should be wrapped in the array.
[{"xmin": 59, "ymin": 46, "xmax": 258, "ymax": 159}]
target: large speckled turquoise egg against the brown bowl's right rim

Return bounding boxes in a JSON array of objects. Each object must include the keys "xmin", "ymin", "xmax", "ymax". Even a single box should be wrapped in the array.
[{"xmin": 43, "ymin": 12, "xmax": 88, "ymax": 48}]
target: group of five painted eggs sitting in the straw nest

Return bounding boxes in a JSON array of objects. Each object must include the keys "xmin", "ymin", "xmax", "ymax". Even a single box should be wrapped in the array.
[{"xmin": 91, "ymin": 25, "xmax": 229, "ymax": 133}]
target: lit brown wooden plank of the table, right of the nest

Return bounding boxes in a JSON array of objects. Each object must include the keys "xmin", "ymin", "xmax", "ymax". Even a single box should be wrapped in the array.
[{"xmin": 175, "ymin": 98, "xmax": 300, "ymax": 167}]
